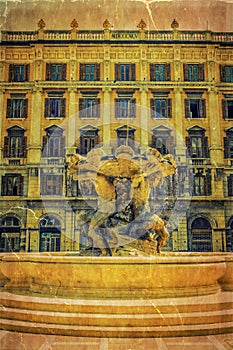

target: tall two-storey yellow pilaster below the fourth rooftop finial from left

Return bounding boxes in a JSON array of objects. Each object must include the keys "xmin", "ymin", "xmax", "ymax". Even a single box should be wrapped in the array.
[{"xmin": 140, "ymin": 87, "xmax": 150, "ymax": 154}]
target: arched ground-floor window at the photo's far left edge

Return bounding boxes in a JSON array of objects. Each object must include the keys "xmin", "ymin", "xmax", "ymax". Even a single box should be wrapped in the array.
[{"xmin": 0, "ymin": 216, "xmax": 21, "ymax": 252}]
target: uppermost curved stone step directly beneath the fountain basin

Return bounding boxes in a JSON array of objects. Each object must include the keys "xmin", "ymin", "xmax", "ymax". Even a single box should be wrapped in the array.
[{"xmin": 0, "ymin": 292, "xmax": 233, "ymax": 315}]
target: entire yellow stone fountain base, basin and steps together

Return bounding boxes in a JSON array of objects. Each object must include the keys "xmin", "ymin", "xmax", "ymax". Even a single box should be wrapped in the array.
[{"xmin": 0, "ymin": 252, "xmax": 233, "ymax": 338}]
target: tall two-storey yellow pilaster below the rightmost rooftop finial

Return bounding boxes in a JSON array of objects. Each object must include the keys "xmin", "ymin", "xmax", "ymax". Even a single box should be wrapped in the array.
[{"xmin": 174, "ymin": 87, "xmax": 186, "ymax": 163}]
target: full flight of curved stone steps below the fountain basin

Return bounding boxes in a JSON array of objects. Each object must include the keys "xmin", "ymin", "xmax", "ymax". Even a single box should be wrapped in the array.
[{"xmin": 0, "ymin": 292, "xmax": 233, "ymax": 337}]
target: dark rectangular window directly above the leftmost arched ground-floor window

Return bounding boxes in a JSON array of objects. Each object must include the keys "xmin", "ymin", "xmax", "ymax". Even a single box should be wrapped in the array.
[{"xmin": 2, "ymin": 174, "xmax": 23, "ymax": 196}]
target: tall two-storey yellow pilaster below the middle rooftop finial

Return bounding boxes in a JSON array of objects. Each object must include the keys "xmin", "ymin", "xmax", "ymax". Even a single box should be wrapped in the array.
[{"xmin": 103, "ymin": 87, "xmax": 111, "ymax": 154}]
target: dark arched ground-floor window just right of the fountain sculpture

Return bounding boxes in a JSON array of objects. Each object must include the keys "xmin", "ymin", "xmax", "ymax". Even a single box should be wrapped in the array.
[{"xmin": 190, "ymin": 218, "xmax": 213, "ymax": 252}]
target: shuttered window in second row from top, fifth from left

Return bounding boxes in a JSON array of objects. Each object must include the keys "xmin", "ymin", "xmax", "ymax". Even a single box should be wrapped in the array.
[{"xmin": 150, "ymin": 98, "xmax": 172, "ymax": 118}]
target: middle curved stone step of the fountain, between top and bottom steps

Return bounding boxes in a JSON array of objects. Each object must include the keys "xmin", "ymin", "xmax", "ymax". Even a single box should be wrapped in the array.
[{"xmin": 0, "ymin": 308, "xmax": 233, "ymax": 327}]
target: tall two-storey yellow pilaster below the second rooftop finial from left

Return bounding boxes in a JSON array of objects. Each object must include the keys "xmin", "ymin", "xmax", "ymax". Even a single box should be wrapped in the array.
[{"xmin": 66, "ymin": 87, "xmax": 78, "ymax": 154}]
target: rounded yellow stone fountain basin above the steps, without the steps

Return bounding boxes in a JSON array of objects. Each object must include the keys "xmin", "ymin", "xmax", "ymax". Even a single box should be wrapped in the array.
[{"xmin": 0, "ymin": 252, "xmax": 227, "ymax": 299}]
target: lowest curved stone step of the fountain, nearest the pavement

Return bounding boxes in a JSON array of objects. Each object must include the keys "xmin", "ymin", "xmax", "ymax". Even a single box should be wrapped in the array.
[{"xmin": 0, "ymin": 319, "xmax": 233, "ymax": 338}]
